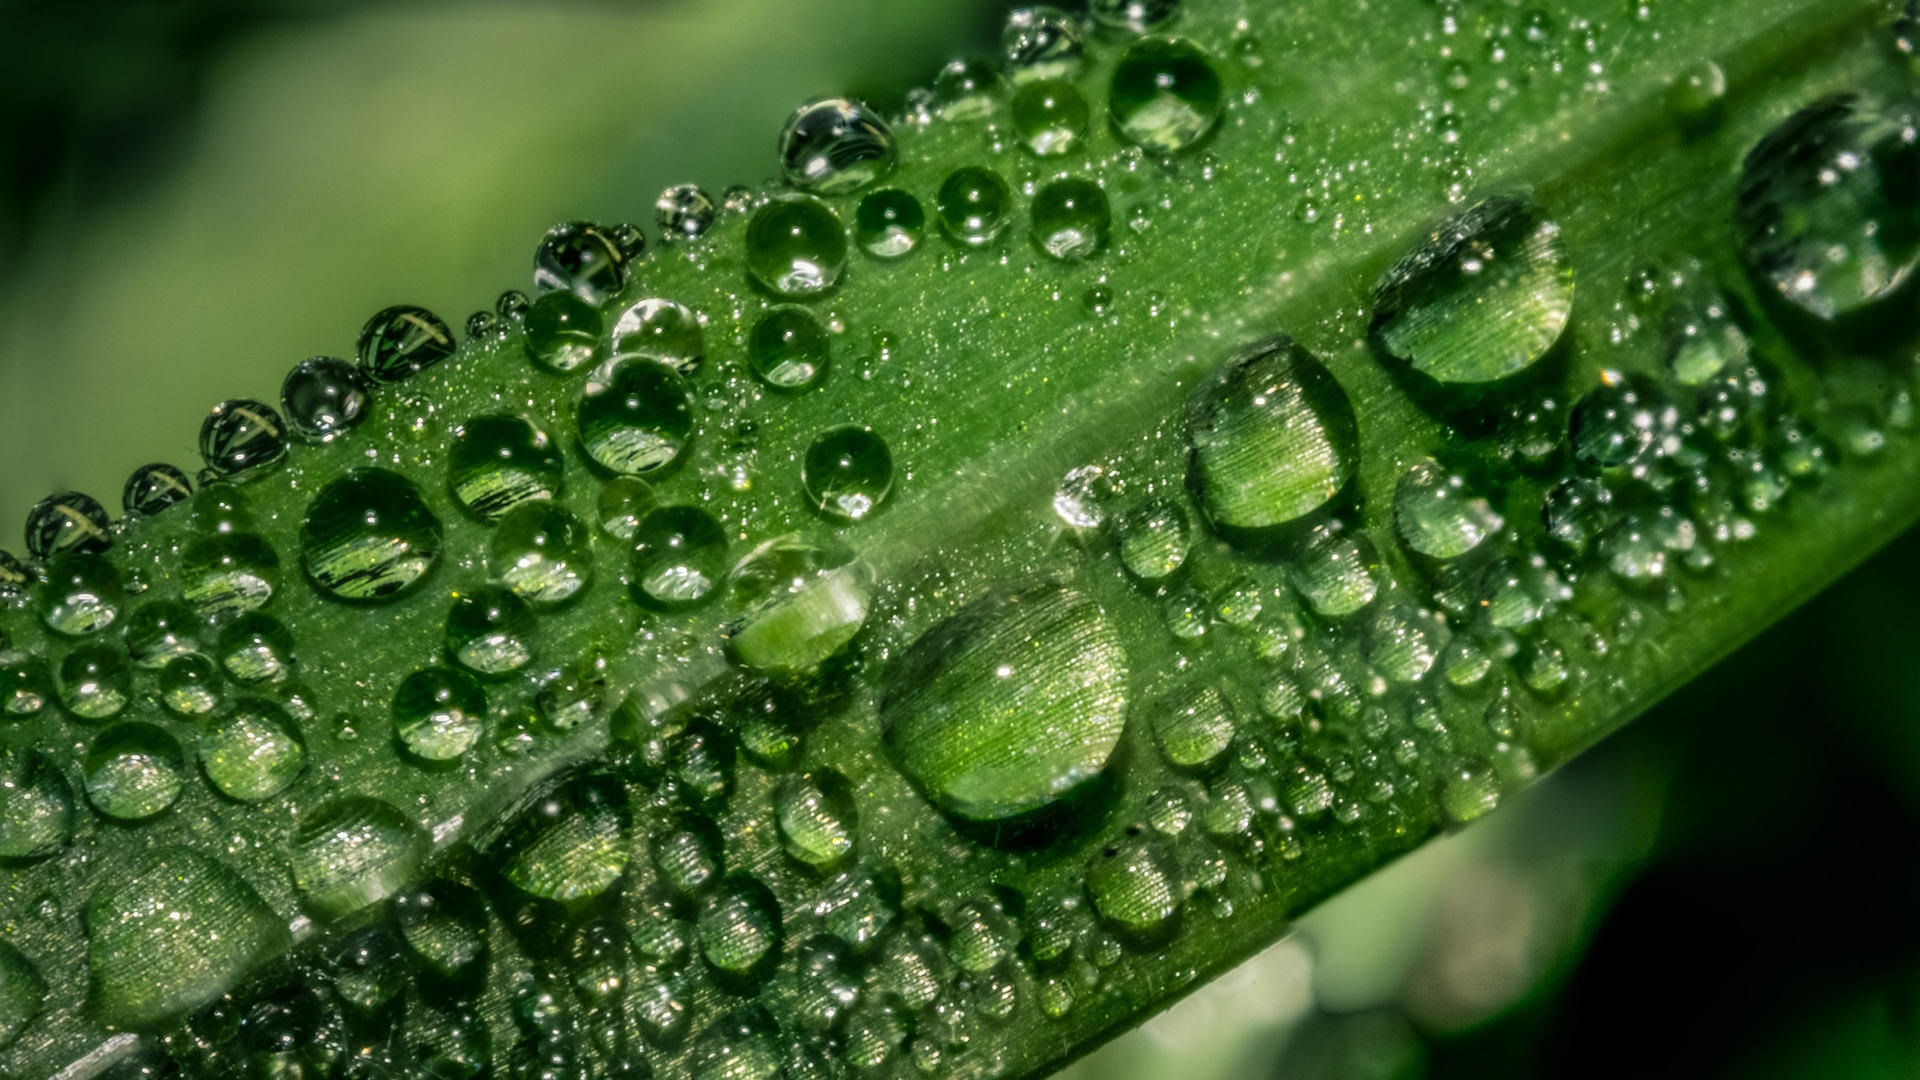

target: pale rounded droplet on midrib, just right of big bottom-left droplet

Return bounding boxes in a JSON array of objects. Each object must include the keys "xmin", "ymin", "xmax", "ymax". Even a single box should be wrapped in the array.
[{"xmin": 288, "ymin": 796, "xmax": 430, "ymax": 917}]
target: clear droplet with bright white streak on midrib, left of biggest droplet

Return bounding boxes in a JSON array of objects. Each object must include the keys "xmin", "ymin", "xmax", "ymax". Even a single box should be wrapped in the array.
[{"xmin": 728, "ymin": 534, "xmax": 874, "ymax": 680}]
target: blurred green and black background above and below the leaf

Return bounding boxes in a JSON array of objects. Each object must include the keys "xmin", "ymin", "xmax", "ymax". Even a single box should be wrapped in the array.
[{"xmin": 0, "ymin": 0, "xmax": 1920, "ymax": 1080}]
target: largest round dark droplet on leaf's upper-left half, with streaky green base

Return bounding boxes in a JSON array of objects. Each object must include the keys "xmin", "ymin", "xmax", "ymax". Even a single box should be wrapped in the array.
[{"xmin": 300, "ymin": 469, "xmax": 442, "ymax": 603}]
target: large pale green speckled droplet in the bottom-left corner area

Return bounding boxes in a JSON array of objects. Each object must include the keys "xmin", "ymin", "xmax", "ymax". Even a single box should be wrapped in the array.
[{"xmin": 86, "ymin": 849, "xmax": 290, "ymax": 1028}]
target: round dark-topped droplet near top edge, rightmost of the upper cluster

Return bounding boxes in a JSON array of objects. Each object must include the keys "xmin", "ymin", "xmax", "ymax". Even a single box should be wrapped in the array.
[{"xmin": 1108, "ymin": 37, "xmax": 1225, "ymax": 154}]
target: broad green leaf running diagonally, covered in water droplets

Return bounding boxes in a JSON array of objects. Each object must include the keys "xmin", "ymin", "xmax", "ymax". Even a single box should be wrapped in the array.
[{"xmin": 0, "ymin": 0, "xmax": 1920, "ymax": 1076}]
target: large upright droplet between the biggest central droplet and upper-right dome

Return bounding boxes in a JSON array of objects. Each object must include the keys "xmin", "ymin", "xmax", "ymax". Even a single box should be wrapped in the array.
[{"xmin": 1187, "ymin": 336, "xmax": 1359, "ymax": 528}]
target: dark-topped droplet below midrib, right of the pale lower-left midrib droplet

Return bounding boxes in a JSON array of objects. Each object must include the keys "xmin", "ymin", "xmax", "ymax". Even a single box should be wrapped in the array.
[{"xmin": 480, "ymin": 771, "xmax": 632, "ymax": 903}]
